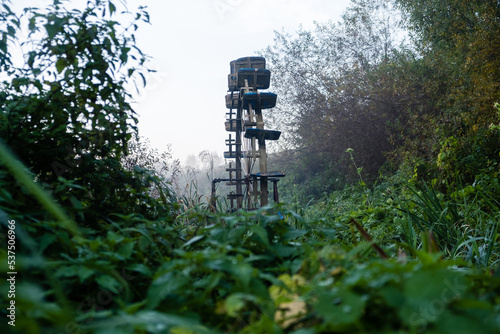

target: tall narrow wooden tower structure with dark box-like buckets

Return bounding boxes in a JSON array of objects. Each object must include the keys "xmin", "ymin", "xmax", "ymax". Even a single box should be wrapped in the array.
[{"xmin": 212, "ymin": 57, "xmax": 285, "ymax": 211}]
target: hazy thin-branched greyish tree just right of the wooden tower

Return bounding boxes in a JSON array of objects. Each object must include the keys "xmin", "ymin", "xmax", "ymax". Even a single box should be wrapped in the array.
[{"xmin": 263, "ymin": 0, "xmax": 404, "ymax": 194}]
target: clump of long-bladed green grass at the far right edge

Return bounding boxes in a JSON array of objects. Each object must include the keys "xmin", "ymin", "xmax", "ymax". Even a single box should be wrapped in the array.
[{"xmin": 401, "ymin": 183, "xmax": 500, "ymax": 267}]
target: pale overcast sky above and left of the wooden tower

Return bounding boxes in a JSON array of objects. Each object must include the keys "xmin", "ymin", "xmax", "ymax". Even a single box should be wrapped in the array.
[{"xmin": 128, "ymin": 0, "xmax": 349, "ymax": 162}]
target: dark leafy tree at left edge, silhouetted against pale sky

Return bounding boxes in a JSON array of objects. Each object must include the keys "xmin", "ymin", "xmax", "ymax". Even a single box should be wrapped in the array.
[{"xmin": 0, "ymin": 0, "xmax": 173, "ymax": 223}]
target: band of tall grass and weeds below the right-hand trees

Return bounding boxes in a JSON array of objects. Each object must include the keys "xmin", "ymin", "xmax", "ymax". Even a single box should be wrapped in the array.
[{"xmin": 291, "ymin": 175, "xmax": 500, "ymax": 267}]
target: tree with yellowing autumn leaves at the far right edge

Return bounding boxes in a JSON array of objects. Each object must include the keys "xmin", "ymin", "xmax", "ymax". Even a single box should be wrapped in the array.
[{"xmin": 396, "ymin": 0, "xmax": 500, "ymax": 181}]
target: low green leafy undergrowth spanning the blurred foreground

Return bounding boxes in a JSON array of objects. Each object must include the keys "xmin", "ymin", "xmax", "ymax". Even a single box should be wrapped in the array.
[{"xmin": 1, "ymin": 166, "xmax": 500, "ymax": 333}]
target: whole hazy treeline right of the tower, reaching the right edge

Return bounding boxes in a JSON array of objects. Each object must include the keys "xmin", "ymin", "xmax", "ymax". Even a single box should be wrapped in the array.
[{"xmin": 263, "ymin": 0, "xmax": 500, "ymax": 198}]
